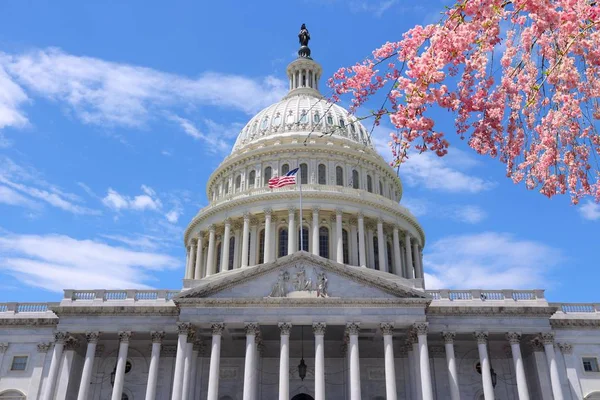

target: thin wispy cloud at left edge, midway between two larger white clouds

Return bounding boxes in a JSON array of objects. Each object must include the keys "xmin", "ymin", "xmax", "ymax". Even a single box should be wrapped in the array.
[{"xmin": 0, "ymin": 157, "xmax": 100, "ymax": 215}]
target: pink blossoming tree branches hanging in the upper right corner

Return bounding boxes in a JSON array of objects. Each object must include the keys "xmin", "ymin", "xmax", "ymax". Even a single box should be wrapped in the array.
[{"xmin": 329, "ymin": 0, "xmax": 600, "ymax": 203}]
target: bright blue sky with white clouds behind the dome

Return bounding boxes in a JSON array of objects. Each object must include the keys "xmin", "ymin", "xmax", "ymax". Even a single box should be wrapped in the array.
[{"xmin": 0, "ymin": 0, "xmax": 600, "ymax": 302}]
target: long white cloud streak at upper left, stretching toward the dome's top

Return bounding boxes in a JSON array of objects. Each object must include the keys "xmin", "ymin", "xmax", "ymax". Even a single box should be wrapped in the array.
[{"xmin": 0, "ymin": 48, "xmax": 287, "ymax": 127}]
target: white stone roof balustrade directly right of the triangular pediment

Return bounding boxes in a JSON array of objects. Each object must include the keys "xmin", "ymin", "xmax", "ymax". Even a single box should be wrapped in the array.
[{"xmin": 425, "ymin": 289, "xmax": 544, "ymax": 302}]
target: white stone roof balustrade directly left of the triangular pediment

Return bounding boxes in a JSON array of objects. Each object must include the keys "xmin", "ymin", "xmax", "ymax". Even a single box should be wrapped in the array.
[{"xmin": 64, "ymin": 289, "xmax": 180, "ymax": 302}]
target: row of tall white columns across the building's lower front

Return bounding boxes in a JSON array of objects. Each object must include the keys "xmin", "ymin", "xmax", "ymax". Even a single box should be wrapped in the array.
[{"xmin": 41, "ymin": 322, "xmax": 563, "ymax": 400}]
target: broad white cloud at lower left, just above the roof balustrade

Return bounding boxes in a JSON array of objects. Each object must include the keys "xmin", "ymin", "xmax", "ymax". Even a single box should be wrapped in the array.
[{"xmin": 0, "ymin": 234, "xmax": 180, "ymax": 292}]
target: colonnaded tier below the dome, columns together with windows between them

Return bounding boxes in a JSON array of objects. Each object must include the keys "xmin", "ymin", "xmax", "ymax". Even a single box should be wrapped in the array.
[{"xmin": 185, "ymin": 207, "xmax": 423, "ymax": 279}]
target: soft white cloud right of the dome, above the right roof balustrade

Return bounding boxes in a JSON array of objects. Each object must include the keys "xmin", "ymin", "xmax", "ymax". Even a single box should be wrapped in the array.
[{"xmin": 423, "ymin": 232, "xmax": 563, "ymax": 289}]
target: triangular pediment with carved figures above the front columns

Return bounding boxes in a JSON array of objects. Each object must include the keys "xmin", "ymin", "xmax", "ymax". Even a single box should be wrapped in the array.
[{"xmin": 174, "ymin": 252, "xmax": 429, "ymax": 302}]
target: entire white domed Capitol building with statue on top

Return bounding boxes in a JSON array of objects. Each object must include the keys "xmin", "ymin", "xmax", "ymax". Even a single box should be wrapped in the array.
[{"xmin": 0, "ymin": 27, "xmax": 600, "ymax": 400}]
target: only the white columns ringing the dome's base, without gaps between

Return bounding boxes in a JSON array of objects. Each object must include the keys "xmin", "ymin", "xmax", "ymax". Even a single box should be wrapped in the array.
[{"xmin": 185, "ymin": 207, "xmax": 423, "ymax": 279}]
